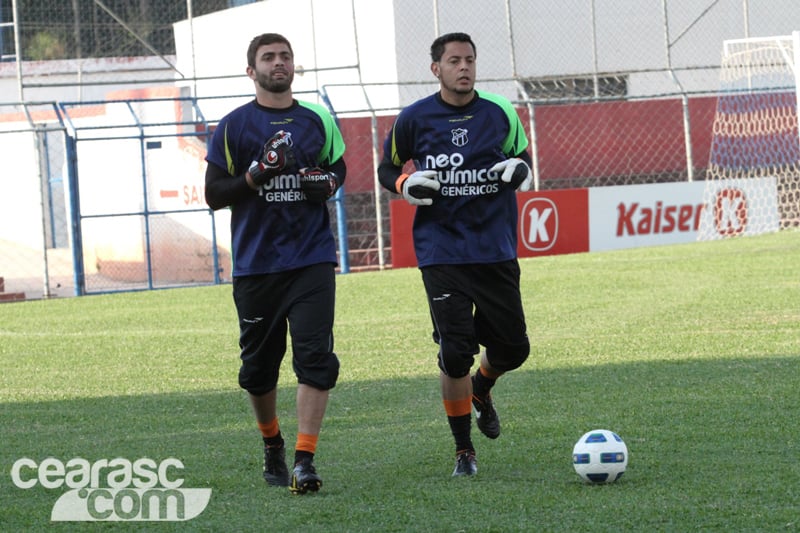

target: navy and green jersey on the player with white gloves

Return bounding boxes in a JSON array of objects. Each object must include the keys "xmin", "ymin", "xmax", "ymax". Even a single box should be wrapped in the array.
[{"xmin": 380, "ymin": 92, "xmax": 530, "ymax": 267}]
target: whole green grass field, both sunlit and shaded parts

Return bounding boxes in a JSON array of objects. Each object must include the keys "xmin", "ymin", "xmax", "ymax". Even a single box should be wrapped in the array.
[{"xmin": 0, "ymin": 231, "xmax": 800, "ymax": 532}]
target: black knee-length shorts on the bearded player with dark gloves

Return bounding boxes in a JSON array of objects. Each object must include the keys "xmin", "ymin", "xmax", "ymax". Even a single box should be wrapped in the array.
[{"xmin": 233, "ymin": 263, "xmax": 339, "ymax": 396}]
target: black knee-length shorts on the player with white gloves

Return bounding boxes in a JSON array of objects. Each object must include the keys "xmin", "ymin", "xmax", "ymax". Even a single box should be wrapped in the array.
[{"xmin": 420, "ymin": 260, "xmax": 530, "ymax": 377}]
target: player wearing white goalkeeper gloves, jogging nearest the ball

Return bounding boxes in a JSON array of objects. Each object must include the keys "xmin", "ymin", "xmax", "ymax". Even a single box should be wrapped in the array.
[{"xmin": 378, "ymin": 33, "xmax": 532, "ymax": 476}]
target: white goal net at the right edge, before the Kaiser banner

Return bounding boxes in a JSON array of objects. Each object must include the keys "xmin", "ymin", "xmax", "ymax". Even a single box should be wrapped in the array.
[{"xmin": 698, "ymin": 32, "xmax": 800, "ymax": 240}]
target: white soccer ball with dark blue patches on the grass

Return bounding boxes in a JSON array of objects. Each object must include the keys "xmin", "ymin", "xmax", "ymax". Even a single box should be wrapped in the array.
[{"xmin": 572, "ymin": 429, "xmax": 628, "ymax": 483}]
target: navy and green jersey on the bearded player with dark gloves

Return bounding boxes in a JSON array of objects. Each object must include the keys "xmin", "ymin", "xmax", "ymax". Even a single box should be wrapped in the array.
[{"xmin": 206, "ymin": 100, "xmax": 345, "ymax": 276}]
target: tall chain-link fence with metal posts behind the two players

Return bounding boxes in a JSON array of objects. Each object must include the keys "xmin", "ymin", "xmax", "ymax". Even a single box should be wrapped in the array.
[{"xmin": 0, "ymin": 0, "xmax": 800, "ymax": 298}]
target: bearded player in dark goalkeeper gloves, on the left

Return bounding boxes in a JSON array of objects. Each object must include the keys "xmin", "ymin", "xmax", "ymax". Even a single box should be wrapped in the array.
[{"xmin": 205, "ymin": 33, "xmax": 347, "ymax": 494}]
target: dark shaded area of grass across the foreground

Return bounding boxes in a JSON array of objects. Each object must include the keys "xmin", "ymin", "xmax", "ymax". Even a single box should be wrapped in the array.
[{"xmin": 0, "ymin": 356, "xmax": 800, "ymax": 531}]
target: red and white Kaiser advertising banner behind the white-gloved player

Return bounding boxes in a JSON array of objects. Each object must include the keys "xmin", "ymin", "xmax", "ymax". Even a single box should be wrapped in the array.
[{"xmin": 390, "ymin": 177, "xmax": 780, "ymax": 268}]
